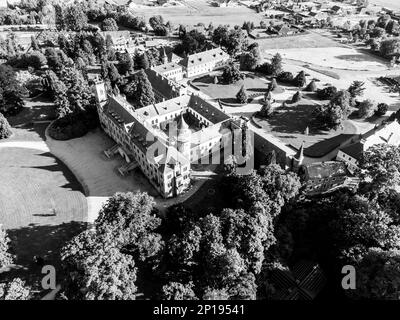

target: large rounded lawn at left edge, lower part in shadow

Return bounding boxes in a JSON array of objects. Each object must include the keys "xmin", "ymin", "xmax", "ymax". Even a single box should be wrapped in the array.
[{"xmin": 0, "ymin": 148, "xmax": 87, "ymax": 290}]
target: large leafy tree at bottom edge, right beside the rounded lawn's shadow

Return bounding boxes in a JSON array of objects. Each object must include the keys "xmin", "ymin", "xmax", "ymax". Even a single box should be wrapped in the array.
[{"xmin": 61, "ymin": 230, "xmax": 137, "ymax": 300}]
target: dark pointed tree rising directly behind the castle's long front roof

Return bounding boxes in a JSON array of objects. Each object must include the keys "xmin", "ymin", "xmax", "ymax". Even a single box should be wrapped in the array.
[{"xmin": 125, "ymin": 69, "xmax": 155, "ymax": 108}]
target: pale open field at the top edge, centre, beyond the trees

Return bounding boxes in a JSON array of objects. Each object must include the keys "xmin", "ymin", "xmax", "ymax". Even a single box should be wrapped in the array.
[{"xmin": 130, "ymin": 0, "xmax": 263, "ymax": 27}]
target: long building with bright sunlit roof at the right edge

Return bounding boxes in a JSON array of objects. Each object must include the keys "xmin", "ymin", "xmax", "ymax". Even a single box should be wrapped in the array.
[{"xmin": 336, "ymin": 120, "xmax": 400, "ymax": 172}]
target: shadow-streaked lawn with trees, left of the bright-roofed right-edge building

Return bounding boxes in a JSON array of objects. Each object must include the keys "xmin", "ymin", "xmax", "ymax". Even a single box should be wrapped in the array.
[{"xmin": 255, "ymin": 99, "xmax": 357, "ymax": 157}]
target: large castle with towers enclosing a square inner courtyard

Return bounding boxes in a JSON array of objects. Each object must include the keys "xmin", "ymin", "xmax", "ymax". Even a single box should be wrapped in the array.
[{"xmin": 95, "ymin": 82, "xmax": 231, "ymax": 198}]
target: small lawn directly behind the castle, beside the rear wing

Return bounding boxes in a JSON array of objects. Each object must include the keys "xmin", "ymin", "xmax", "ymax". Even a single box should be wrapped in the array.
[{"xmin": 192, "ymin": 72, "xmax": 269, "ymax": 103}]
